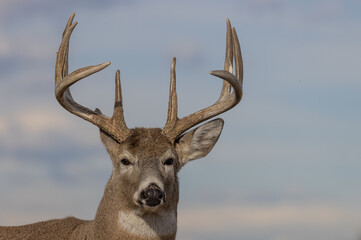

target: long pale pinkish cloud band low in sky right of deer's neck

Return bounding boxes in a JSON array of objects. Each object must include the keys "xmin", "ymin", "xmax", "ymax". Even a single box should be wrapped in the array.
[{"xmin": 179, "ymin": 205, "xmax": 344, "ymax": 232}]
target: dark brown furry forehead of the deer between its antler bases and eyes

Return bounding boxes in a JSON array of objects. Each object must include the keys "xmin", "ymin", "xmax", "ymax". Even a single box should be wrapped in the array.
[{"xmin": 123, "ymin": 128, "xmax": 172, "ymax": 157}]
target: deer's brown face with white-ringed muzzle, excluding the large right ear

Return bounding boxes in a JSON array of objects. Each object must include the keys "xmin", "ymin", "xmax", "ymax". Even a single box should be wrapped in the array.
[{"xmin": 101, "ymin": 128, "xmax": 179, "ymax": 210}]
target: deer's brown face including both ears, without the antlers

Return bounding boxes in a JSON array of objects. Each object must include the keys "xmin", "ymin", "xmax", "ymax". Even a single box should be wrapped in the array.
[{"xmin": 101, "ymin": 119, "xmax": 223, "ymax": 213}]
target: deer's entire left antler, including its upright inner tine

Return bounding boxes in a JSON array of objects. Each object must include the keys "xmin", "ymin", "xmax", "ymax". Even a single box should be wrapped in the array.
[{"xmin": 55, "ymin": 13, "xmax": 130, "ymax": 142}]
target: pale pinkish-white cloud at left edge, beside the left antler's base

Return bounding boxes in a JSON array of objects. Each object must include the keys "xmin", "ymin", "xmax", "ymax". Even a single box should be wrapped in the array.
[{"xmin": 0, "ymin": 108, "xmax": 100, "ymax": 151}]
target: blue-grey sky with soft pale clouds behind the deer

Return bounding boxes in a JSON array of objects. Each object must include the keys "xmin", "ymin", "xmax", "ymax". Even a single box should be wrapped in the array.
[{"xmin": 0, "ymin": 0, "xmax": 361, "ymax": 240}]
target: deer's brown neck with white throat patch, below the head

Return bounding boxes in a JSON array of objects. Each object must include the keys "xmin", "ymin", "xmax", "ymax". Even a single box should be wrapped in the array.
[{"xmin": 94, "ymin": 175, "xmax": 177, "ymax": 240}]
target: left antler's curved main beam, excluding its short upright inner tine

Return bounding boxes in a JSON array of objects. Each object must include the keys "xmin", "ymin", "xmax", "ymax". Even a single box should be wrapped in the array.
[{"xmin": 55, "ymin": 13, "xmax": 131, "ymax": 141}]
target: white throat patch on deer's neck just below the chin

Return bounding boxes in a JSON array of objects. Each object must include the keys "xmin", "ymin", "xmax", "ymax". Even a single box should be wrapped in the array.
[{"xmin": 118, "ymin": 211, "xmax": 177, "ymax": 238}]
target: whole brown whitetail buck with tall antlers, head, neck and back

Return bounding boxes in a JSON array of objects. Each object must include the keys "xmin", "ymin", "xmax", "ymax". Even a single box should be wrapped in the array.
[{"xmin": 0, "ymin": 14, "xmax": 243, "ymax": 240}]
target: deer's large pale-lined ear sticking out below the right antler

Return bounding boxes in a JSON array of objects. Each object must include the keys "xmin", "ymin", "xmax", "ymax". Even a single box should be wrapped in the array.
[{"xmin": 176, "ymin": 118, "xmax": 224, "ymax": 166}]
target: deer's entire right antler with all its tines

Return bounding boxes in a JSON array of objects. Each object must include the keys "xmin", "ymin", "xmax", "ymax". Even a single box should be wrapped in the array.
[{"xmin": 163, "ymin": 19, "xmax": 243, "ymax": 140}]
